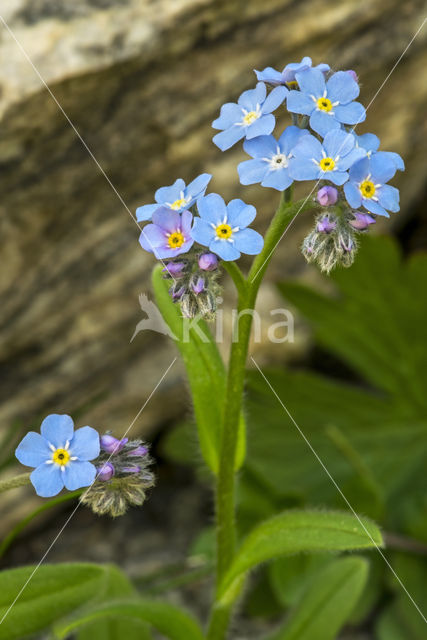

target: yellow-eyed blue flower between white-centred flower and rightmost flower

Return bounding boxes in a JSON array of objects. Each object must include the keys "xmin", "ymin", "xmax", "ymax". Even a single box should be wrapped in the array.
[{"xmin": 289, "ymin": 130, "xmax": 364, "ymax": 185}]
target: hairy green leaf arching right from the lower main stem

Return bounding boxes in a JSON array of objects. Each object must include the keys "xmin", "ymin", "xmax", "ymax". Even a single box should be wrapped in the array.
[{"xmin": 219, "ymin": 511, "xmax": 383, "ymax": 602}]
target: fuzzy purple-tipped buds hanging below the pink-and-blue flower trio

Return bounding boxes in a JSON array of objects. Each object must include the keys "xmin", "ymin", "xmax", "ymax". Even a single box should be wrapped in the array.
[{"xmin": 163, "ymin": 252, "xmax": 221, "ymax": 320}]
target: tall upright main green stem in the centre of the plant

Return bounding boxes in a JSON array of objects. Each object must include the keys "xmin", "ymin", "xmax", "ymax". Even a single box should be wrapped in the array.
[{"xmin": 207, "ymin": 191, "xmax": 313, "ymax": 640}]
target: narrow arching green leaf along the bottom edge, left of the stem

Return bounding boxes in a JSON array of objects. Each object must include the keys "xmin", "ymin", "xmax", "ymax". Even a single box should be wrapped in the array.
[{"xmin": 55, "ymin": 598, "xmax": 204, "ymax": 640}]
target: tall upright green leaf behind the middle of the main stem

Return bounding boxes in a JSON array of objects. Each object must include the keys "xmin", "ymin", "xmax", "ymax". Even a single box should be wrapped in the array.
[{"xmin": 153, "ymin": 266, "xmax": 245, "ymax": 473}]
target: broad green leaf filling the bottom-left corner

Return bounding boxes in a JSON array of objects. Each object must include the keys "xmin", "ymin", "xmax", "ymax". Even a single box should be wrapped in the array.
[{"xmin": 0, "ymin": 563, "xmax": 108, "ymax": 640}]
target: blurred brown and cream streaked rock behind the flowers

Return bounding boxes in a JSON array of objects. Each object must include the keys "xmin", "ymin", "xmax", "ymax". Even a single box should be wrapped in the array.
[{"xmin": 0, "ymin": 0, "xmax": 427, "ymax": 484}]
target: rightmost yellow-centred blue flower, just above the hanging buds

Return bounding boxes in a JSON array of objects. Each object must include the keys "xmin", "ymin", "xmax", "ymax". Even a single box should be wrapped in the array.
[{"xmin": 344, "ymin": 152, "xmax": 399, "ymax": 218}]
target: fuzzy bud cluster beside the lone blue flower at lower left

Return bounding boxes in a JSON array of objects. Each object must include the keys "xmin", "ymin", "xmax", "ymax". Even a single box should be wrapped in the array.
[{"xmin": 81, "ymin": 433, "xmax": 154, "ymax": 518}]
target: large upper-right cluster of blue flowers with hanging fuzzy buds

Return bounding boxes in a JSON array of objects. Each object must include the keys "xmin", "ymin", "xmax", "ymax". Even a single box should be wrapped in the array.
[{"xmin": 212, "ymin": 57, "xmax": 404, "ymax": 272}]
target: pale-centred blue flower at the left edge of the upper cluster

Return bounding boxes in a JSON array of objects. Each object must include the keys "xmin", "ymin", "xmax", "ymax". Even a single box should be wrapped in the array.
[{"xmin": 212, "ymin": 82, "xmax": 289, "ymax": 151}]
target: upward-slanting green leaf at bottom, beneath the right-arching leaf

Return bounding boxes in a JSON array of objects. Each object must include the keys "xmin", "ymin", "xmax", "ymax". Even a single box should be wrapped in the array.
[{"xmin": 271, "ymin": 558, "xmax": 368, "ymax": 640}]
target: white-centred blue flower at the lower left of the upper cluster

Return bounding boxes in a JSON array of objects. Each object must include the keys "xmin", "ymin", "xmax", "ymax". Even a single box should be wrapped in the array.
[{"xmin": 237, "ymin": 126, "xmax": 310, "ymax": 191}]
